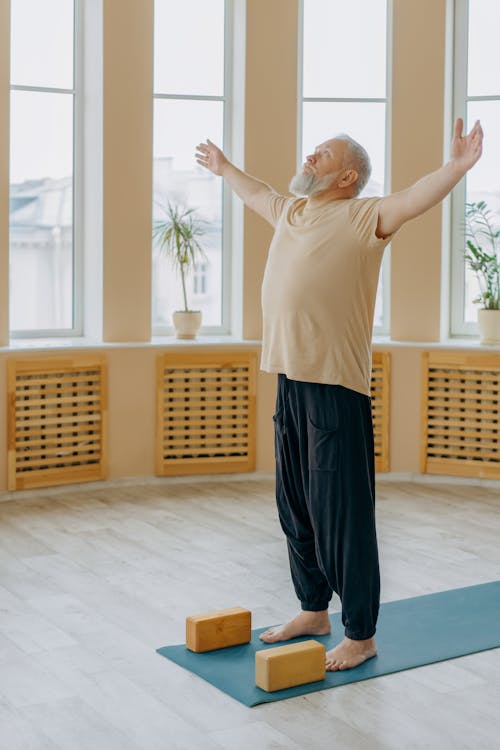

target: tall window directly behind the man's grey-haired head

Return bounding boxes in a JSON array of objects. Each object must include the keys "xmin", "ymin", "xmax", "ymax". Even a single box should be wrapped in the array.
[{"xmin": 299, "ymin": 0, "xmax": 389, "ymax": 333}]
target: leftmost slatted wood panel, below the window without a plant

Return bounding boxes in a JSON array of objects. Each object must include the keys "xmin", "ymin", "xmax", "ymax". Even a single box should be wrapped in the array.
[{"xmin": 7, "ymin": 356, "xmax": 107, "ymax": 490}]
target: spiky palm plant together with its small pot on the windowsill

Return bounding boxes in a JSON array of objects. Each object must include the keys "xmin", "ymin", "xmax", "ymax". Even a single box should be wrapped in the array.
[{"xmin": 153, "ymin": 202, "xmax": 207, "ymax": 339}]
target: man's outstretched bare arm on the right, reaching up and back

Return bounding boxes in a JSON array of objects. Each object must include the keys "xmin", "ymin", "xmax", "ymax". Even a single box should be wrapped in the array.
[{"xmin": 377, "ymin": 118, "xmax": 483, "ymax": 237}]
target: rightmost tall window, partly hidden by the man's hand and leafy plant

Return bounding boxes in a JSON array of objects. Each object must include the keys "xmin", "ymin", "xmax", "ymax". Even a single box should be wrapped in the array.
[{"xmin": 451, "ymin": 0, "xmax": 500, "ymax": 335}]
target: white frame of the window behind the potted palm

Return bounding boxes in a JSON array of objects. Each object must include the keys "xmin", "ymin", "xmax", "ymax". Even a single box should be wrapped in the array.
[{"xmin": 151, "ymin": 0, "xmax": 235, "ymax": 337}]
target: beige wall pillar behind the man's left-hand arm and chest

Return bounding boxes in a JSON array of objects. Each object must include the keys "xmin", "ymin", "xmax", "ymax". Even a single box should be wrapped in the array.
[{"xmin": 243, "ymin": 0, "xmax": 298, "ymax": 339}]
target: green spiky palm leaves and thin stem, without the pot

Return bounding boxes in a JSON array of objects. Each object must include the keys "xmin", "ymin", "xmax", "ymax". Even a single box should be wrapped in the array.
[{"xmin": 153, "ymin": 202, "xmax": 207, "ymax": 312}]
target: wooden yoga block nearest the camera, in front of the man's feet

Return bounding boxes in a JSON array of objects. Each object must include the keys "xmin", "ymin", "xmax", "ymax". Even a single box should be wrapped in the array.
[{"xmin": 255, "ymin": 641, "xmax": 326, "ymax": 693}]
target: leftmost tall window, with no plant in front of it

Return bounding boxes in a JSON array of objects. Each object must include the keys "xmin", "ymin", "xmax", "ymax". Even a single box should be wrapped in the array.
[{"xmin": 10, "ymin": 0, "xmax": 79, "ymax": 336}]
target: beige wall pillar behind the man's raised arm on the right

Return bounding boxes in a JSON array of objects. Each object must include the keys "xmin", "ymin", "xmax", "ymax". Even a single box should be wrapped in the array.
[{"xmin": 391, "ymin": 0, "xmax": 446, "ymax": 341}]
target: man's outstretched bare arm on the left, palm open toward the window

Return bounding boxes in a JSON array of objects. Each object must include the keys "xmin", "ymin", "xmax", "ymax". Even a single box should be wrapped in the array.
[{"xmin": 196, "ymin": 140, "xmax": 275, "ymax": 224}]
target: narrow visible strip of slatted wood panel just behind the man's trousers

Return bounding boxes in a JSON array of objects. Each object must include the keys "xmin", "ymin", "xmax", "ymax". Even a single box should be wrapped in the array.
[{"xmin": 371, "ymin": 352, "xmax": 391, "ymax": 472}]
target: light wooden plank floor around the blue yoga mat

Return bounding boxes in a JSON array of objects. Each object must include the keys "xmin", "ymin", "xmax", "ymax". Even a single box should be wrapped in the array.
[{"xmin": 0, "ymin": 479, "xmax": 500, "ymax": 750}]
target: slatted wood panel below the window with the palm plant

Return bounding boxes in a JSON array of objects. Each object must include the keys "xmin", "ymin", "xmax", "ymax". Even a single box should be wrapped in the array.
[{"xmin": 156, "ymin": 351, "xmax": 256, "ymax": 476}]
